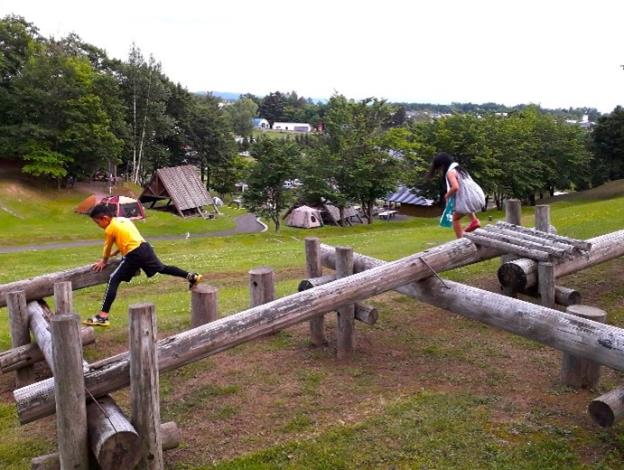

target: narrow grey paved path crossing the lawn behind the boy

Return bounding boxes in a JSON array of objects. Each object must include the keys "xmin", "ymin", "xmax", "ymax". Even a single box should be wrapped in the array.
[{"xmin": 0, "ymin": 214, "xmax": 265, "ymax": 253}]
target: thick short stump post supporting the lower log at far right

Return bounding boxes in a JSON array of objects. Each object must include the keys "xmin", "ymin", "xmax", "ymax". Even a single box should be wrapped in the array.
[{"xmin": 561, "ymin": 305, "xmax": 607, "ymax": 388}]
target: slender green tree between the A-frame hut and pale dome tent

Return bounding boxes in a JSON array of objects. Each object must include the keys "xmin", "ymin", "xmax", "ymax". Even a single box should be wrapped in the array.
[{"xmin": 243, "ymin": 138, "xmax": 299, "ymax": 232}]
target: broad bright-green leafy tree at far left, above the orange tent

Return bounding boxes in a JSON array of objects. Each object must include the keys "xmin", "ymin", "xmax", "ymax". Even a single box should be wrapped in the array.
[{"xmin": 3, "ymin": 35, "xmax": 122, "ymax": 183}]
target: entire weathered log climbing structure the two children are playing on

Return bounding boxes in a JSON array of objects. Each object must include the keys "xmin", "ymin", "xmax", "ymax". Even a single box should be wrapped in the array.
[{"xmin": 0, "ymin": 200, "xmax": 624, "ymax": 469}]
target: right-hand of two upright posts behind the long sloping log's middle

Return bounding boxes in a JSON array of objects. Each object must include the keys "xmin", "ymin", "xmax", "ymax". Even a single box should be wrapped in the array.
[{"xmin": 336, "ymin": 246, "xmax": 355, "ymax": 361}]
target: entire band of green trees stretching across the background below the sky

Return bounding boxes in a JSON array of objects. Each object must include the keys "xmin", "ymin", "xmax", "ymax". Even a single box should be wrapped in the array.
[{"xmin": 0, "ymin": 16, "xmax": 624, "ymax": 218}]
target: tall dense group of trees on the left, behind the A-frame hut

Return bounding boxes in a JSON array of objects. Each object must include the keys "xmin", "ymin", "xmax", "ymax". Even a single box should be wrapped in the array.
[{"xmin": 0, "ymin": 16, "xmax": 236, "ymax": 184}]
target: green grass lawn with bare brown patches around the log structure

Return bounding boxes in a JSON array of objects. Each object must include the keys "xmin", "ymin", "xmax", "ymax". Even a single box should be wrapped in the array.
[{"xmin": 0, "ymin": 178, "xmax": 624, "ymax": 469}]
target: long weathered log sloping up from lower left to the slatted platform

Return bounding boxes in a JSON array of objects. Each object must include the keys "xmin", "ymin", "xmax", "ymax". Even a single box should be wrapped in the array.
[{"xmin": 13, "ymin": 239, "xmax": 508, "ymax": 424}]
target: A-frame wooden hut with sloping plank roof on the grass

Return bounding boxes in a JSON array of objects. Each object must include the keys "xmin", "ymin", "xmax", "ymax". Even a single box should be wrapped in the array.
[{"xmin": 139, "ymin": 165, "xmax": 219, "ymax": 218}]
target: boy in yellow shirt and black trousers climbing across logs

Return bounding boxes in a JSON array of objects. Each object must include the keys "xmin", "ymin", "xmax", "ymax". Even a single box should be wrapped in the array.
[{"xmin": 83, "ymin": 204, "xmax": 202, "ymax": 326}]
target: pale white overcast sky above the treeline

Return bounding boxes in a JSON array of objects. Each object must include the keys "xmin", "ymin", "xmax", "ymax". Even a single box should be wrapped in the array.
[{"xmin": 0, "ymin": 0, "xmax": 624, "ymax": 112}]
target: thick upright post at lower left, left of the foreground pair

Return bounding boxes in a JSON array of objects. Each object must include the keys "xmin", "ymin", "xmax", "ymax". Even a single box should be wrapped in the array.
[{"xmin": 50, "ymin": 313, "xmax": 89, "ymax": 470}]
